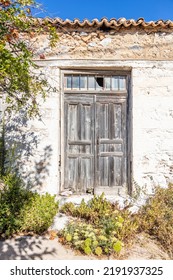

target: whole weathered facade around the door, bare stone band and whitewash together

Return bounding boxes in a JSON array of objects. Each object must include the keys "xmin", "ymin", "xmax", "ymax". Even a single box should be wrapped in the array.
[{"xmin": 2, "ymin": 29, "xmax": 173, "ymax": 197}]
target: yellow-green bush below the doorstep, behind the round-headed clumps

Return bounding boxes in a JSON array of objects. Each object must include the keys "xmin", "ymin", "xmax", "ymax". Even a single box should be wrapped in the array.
[{"xmin": 60, "ymin": 193, "xmax": 138, "ymax": 241}]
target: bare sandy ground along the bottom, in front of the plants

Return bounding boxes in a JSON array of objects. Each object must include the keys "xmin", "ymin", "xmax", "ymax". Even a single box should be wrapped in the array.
[{"xmin": 0, "ymin": 233, "xmax": 170, "ymax": 260}]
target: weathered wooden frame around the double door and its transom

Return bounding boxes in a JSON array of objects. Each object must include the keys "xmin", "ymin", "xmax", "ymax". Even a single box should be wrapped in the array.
[{"xmin": 58, "ymin": 67, "xmax": 133, "ymax": 195}]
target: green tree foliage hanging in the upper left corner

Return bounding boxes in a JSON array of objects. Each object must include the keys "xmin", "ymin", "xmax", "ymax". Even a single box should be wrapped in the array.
[{"xmin": 0, "ymin": 0, "xmax": 58, "ymax": 116}]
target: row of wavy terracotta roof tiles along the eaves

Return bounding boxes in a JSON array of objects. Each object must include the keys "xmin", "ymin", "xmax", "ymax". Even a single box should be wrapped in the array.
[{"xmin": 35, "ymin": 18, "xmax": 173, "ymax": 29}]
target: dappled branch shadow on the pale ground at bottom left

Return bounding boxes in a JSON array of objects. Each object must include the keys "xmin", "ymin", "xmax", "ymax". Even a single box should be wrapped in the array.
[{"xmin": 0, "ymin": 236, "xmax": 57, "ymax": 260}]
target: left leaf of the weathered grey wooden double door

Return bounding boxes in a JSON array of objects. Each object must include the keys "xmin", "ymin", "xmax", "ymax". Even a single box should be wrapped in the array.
[{"xmin": 64, "ymin": 95, "xmax": 95, "ymax": 193}]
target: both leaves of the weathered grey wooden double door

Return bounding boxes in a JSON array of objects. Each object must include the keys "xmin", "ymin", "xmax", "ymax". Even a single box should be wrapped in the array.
[{"xmin": 64, "ymin": 72, "xmax": 127, "ymax": 194}]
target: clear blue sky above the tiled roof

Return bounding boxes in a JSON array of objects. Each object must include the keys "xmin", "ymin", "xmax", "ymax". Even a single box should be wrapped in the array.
[{"xmin": 37, "ymin": 0, "xmax": 173, "ymax": 21}]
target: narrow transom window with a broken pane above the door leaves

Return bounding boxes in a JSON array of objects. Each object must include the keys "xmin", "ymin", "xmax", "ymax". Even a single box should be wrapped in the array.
[{"xmin": 64, "ymin": 74, "xmax": 127, "ymax": 92}]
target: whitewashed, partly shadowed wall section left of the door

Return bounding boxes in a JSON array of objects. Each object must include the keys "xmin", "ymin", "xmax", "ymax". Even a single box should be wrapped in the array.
[{"xmin": 5, "ymin": 65, "xmax": 60, "ymax": 194}]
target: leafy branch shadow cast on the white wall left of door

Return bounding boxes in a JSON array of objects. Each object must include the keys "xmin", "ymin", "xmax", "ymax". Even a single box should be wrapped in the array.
[{"xmin": 3, "ymin": 112, "xmax": 52, "ymax": 191}]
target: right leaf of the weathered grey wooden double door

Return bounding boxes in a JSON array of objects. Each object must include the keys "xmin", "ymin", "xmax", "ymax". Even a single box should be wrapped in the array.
[{"xmin": 95, "ymin": 96, "xmax": 126, "ymax": 194}]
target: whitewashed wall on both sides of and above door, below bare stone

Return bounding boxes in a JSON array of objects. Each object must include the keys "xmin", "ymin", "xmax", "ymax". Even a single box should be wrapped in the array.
[{"xmin": 4, "ymin": 60, "xmax": 173, "ymax": 194}]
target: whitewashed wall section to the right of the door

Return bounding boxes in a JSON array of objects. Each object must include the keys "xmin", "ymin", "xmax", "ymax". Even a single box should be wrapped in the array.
[{"xmin": 132, "ymin": 62, "xmax": 173, "ymax": 191}]
